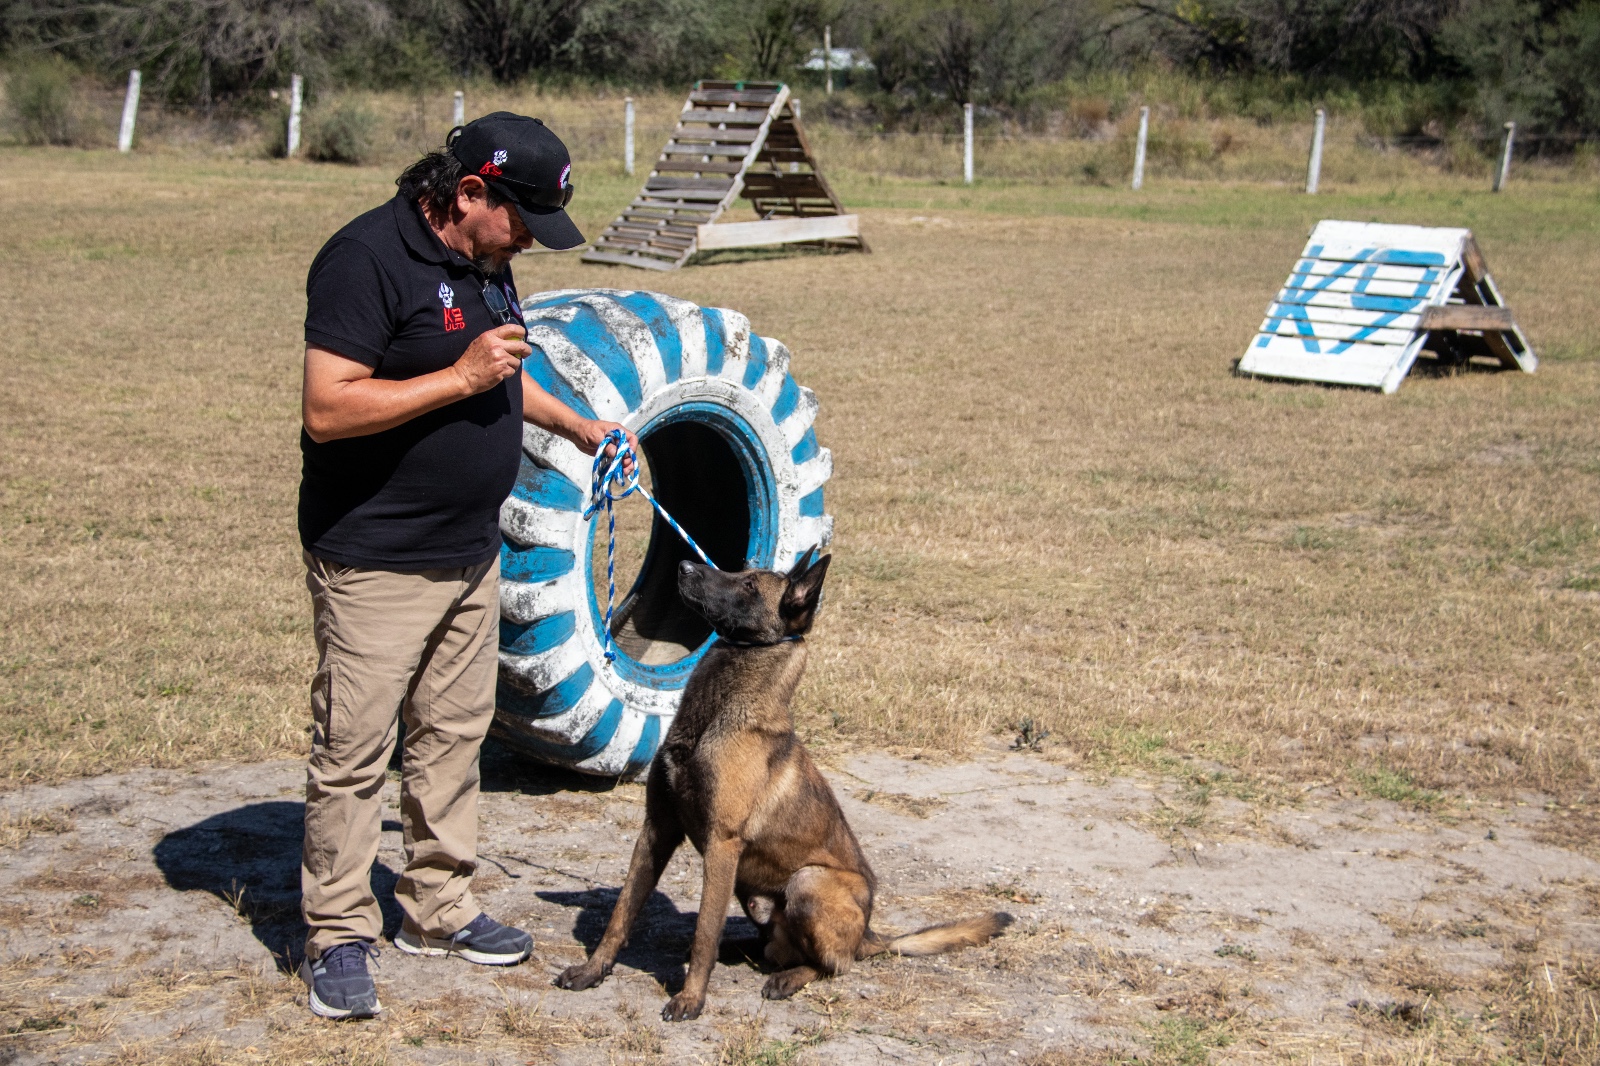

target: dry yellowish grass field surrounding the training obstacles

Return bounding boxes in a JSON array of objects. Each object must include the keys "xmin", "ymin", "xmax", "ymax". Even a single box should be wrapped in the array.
[{"xmin": 0, "ymin": 132, "xmax": 1600, "ymax": 1063}]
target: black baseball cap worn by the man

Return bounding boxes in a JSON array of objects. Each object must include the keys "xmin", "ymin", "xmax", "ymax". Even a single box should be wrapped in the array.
[{"xmin": 445, "ymin": 110, "xmax": 584, "ymax": 250}]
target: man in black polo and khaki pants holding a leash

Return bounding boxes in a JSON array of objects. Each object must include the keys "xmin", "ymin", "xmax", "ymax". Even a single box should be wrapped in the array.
[{"xmin": 299, "ymin": 112, "xmax": 633, "ymax": 1018}]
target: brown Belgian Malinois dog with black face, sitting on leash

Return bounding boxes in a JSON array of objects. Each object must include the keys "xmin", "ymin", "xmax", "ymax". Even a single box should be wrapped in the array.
[{"xmin": 555, "ymin": 549, "xmax": 1011, "ymax": 1021}]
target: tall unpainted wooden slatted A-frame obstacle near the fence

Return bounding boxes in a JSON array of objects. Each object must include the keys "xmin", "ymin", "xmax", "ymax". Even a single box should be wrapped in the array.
[{"xmin": 582, "ymin": 82, "xmax": 867, "ymax": 271}]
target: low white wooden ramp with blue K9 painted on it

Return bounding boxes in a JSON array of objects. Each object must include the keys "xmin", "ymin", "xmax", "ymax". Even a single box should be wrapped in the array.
[{"xmin": 1238, "ymin": 219, "xmax": 1539, "ymax": 392}]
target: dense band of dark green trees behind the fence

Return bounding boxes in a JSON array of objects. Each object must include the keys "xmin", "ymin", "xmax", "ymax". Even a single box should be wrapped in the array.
[{"xmin": 0, "ymin": 0, "xmax": 1600, "ymax": 140}]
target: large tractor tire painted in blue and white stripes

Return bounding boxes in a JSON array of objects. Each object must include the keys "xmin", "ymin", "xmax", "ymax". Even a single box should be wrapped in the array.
[{"xmin": 496, "ymin": 288, "xmax": 834, "ymax": 776}]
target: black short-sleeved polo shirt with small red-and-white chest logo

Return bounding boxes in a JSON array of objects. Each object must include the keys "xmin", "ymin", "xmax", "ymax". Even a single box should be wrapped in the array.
[{"xmin": 299, "ymin": 197, "xmax": 522, "ymax": 570}]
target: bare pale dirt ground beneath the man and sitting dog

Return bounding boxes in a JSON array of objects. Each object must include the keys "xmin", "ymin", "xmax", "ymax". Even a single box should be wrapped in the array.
[{"xmin": 0, "ymin": 741, "xmax": 1600, "ymax": 1063}]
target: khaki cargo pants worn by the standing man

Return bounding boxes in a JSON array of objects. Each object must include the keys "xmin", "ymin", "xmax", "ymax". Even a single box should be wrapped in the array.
[{"xmin": 301, "ymin": 554, "xmax": 499, "ymax": 959}]
